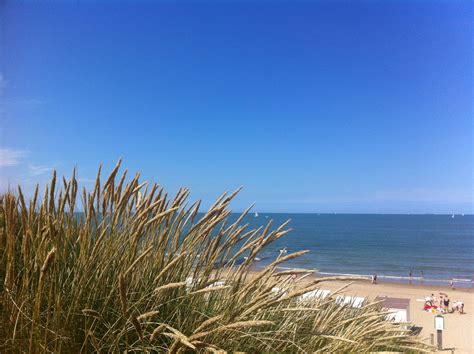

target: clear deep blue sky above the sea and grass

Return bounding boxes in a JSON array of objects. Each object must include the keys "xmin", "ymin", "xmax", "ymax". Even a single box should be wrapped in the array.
[{"xmin": 0, "ymin": 1, "xmax": 474, "ymax": 213}]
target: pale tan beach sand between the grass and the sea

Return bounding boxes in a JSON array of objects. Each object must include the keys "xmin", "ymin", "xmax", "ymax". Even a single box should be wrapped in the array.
[{"xmin": 304, "ymin": 281, "xmax": 474, "ymax": 353}]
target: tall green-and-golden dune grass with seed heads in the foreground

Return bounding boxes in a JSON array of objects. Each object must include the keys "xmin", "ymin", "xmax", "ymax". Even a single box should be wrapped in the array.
[{"xmin": 0, "ymin": 162, "xmax": 429, "ymax": 352}]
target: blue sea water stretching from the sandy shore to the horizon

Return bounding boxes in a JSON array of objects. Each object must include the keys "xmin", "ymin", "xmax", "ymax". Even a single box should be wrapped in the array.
[{"xmin": 233, "ymin": 213, "xmax": 474, "ymax": 287}]
